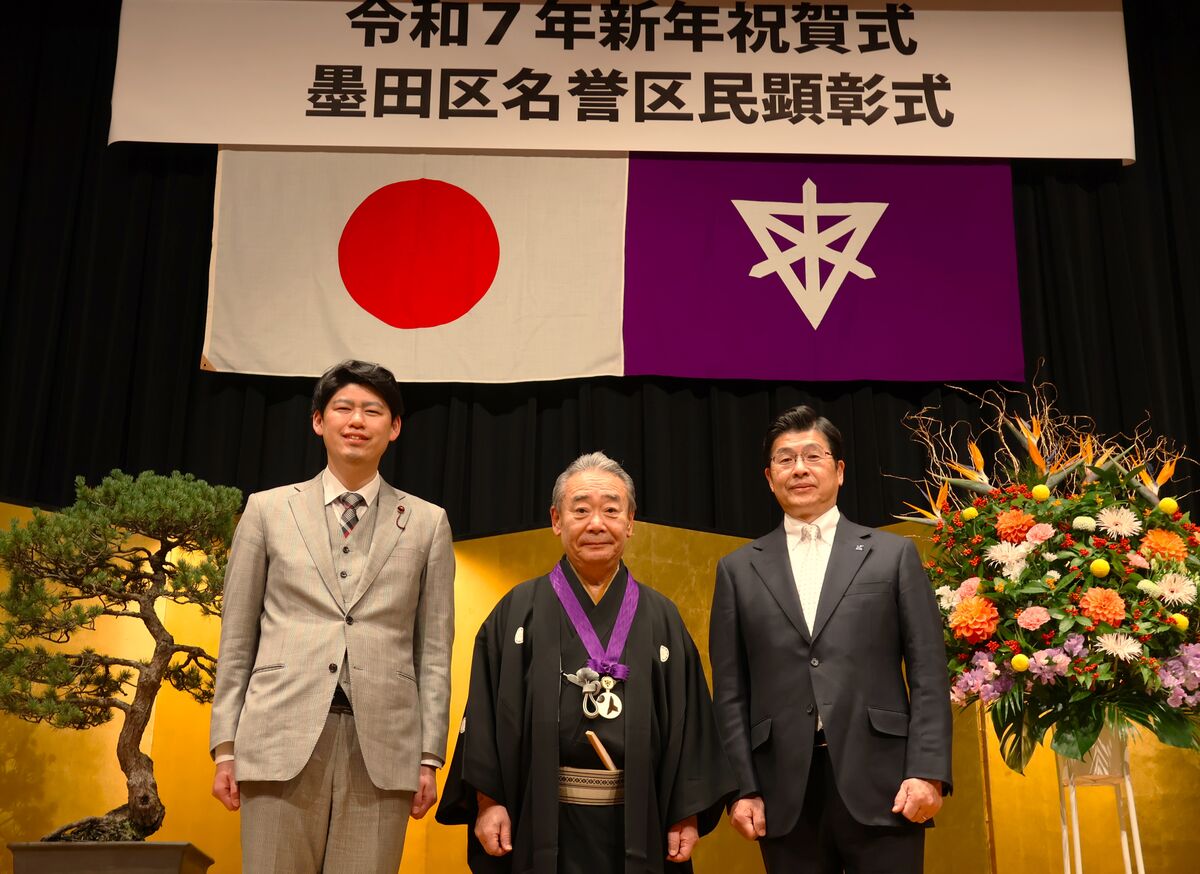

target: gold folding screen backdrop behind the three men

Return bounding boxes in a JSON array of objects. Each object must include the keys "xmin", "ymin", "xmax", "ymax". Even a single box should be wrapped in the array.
[{"xmin": 0, "ymin": 504, "xmax": 1200, "ymax": 874}]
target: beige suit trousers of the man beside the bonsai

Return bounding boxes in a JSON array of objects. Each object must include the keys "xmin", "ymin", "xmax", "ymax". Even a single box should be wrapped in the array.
[{"xmin": 239, "ymin": 713, "xmax": 413, "ymax": 874}]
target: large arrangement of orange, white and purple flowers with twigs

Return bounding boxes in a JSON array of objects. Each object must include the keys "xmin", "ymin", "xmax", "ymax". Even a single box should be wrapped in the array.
[{"xmin": 899, "ymin": 385, "xmax": 1200, "ymax": 771}]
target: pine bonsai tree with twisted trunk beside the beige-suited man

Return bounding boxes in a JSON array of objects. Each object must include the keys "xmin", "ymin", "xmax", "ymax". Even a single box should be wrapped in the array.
[{"xmin": 0, "ymin": 471, "xmax": 241, "ymax": 840}]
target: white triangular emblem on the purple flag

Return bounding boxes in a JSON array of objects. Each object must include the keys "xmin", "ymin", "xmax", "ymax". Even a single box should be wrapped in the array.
[{"xmin": 732, "ymin": 179, "xmax": 888, "ymax": 330}]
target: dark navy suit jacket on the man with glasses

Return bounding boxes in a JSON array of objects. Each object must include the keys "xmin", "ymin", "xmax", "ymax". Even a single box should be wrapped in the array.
[{"xmin": 709, "ymin": 516, "xmax": 952, "ymax": 837}]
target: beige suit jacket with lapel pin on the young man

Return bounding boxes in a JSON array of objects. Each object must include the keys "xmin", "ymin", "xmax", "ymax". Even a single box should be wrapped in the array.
[{"xmin": 209, "ymin": 475, "xmax": 455, "ymax": 791}]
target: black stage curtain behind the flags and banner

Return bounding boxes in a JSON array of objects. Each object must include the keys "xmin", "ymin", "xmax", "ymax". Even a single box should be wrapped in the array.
[{"xmin": 0, "ymin": 0, "xmax": 1200, "ymax": 538}]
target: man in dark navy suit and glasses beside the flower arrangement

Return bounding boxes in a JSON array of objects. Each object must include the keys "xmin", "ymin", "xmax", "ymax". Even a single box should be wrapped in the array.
[{"xmin": 709, "ymin": 407, "xmax": 952, "ymax": 874}]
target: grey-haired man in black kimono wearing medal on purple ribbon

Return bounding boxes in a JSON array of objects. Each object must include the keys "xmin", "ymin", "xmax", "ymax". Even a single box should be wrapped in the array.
[{"xmin": 437, "ymin": 453, "xmax": 733, "ymax": 874}]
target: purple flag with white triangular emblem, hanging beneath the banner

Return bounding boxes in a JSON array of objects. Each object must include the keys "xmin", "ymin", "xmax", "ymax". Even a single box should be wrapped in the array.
[{"xmin": 624, "ymin": 155, "xmax": 1025, "ymax": 382}]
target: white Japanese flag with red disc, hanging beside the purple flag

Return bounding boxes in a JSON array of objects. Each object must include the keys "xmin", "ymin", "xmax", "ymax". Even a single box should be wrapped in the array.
[{"xmin": 204, "ymin": 149, "xmax": 628, "ymax": 382}]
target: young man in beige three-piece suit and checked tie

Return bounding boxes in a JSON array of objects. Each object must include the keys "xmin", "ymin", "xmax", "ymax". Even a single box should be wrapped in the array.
[{"xmin": 210, "ymin": 361, "xmax": 454, "ymax": 874}]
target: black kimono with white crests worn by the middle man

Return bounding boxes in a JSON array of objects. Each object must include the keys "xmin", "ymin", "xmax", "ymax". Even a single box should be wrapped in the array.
[{"xmin": 437, "ymin": 558, "xmax": 734, "ymax": 874}]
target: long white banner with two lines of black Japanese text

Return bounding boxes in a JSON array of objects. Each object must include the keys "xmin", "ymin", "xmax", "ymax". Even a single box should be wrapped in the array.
[{"xmin": 109, "ymin": 0, "xmax": 1134, "ymax": 161}]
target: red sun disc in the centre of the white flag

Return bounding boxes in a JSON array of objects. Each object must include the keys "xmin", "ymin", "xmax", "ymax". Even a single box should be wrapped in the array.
[{"xmin": 337, "ymin": 179, "xmax": 500, "ymax": 328}]
